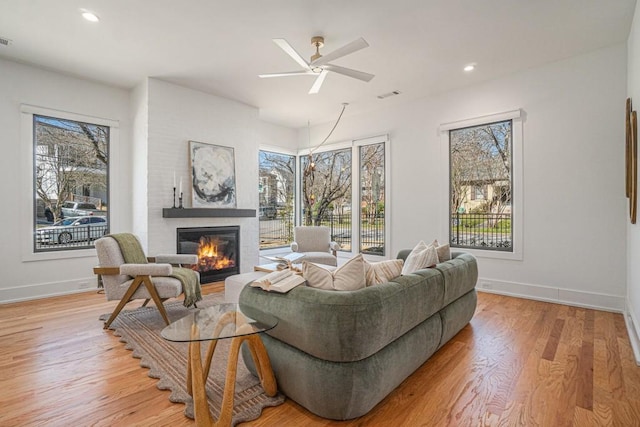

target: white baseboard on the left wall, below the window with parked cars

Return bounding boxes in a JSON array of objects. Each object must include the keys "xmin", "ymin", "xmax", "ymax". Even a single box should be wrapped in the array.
[{"xmin": 0, "ymin": 276, "xmax": 98, "ymax": 304}]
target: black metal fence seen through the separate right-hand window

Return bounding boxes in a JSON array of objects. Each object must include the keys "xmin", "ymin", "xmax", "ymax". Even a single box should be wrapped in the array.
[{"xmin": 450, "ymin": 213, "xmax": 513, "ymax": 252}]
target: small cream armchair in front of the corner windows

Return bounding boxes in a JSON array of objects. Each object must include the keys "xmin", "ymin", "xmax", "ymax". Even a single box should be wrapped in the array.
[{"xmin": 291, "ymin": 226, "xmax": 340, "ymax": 266}]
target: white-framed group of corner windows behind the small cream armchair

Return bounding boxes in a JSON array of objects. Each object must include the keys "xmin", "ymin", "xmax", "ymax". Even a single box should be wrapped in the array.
[{"xmin": 258, "ymin": 135, "xmax": 389, "ymax": 256}]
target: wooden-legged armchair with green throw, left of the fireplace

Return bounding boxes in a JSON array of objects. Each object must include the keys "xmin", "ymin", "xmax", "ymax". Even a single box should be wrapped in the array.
[{"xmin": 93, "ymin": 233, "xmax": 202, "ymax": 329}]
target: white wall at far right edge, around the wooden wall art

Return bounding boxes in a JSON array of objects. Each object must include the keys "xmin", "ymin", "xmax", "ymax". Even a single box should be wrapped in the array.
[{"xmin": 626, "ymin": 1, "xmax": 640, "ymax": 362}]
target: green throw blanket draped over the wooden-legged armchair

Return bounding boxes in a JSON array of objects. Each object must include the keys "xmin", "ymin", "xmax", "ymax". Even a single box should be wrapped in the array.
[{"xmin": 109, "ymin": 233, "xmax": 202, "ymax": 307}]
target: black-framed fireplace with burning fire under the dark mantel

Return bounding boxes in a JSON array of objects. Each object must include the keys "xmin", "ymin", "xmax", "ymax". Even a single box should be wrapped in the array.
[{"xmin": 177, "ymin": 226, "xmax": 240, "ymax": 283}]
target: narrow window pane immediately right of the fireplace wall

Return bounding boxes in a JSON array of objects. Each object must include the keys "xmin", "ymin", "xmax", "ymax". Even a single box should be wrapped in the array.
[{"xmin": 258, "ymin": 150, "xmax": 296, "ymax": 249}]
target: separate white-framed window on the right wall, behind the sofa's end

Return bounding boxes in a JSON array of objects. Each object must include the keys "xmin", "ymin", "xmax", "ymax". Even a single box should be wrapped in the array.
[{"xmin": 440, "ymin": 110, "xmax": 522, "ymax": 259}]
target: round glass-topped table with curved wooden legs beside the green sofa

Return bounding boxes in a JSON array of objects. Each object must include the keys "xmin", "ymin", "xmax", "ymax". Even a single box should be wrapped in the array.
[{"xmin": 161, "ymin": 303, "xmax": 278, "ymax": 426}]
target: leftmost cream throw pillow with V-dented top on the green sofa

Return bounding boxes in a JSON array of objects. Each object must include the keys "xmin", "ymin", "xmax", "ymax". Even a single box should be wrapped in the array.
[{"xmin": 302, "ymin": 254, "xmax": 366, "ymax": 291}]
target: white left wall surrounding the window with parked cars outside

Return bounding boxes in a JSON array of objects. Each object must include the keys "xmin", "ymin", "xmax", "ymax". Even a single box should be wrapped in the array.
[{"xmin": 0, "ymin": 59, "xmax": 131, "ymax": 302}]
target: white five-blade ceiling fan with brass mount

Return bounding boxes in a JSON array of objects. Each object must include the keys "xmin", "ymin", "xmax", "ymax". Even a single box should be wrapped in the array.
[{"xmin": 259, "ymin": 36, "xmax": 375, "ymax": 94}]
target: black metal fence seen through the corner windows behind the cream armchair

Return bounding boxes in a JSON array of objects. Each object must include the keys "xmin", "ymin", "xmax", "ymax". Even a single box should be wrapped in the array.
[{"xmin": 260, "ymin": 214, "xmax": 385, "ymax": 255}]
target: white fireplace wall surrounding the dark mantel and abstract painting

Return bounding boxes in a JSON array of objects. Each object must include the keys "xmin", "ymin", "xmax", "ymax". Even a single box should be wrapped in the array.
[{"xmin": 142, "ymin": 79, "xmax": 297, "ymax": 272}]
